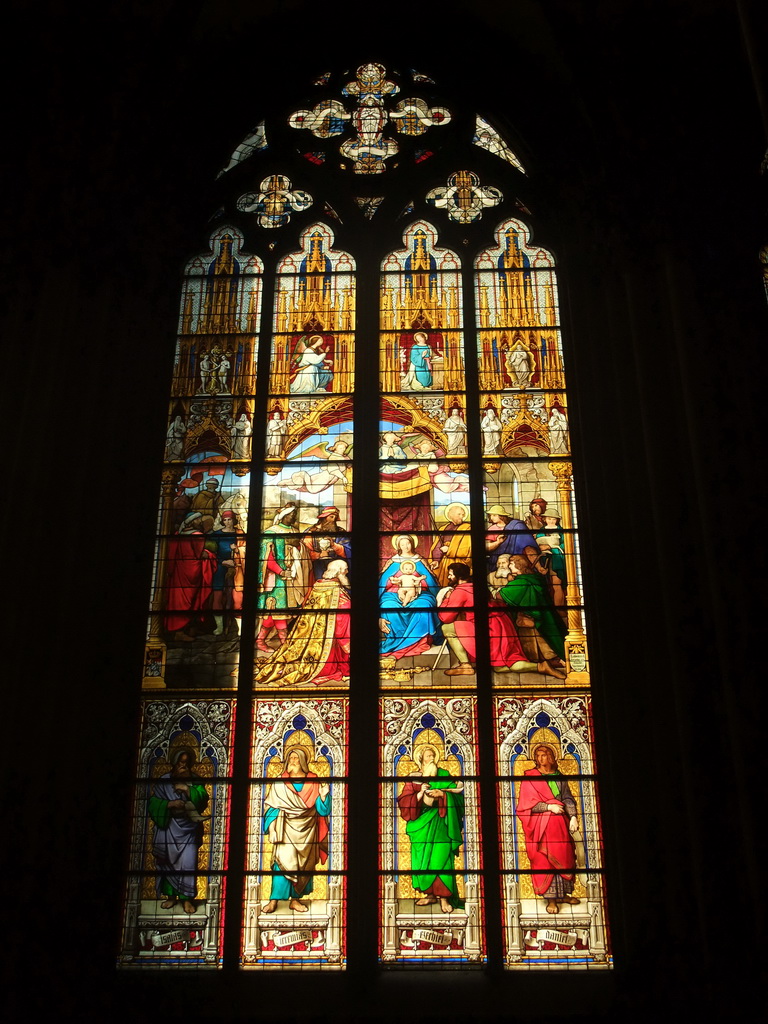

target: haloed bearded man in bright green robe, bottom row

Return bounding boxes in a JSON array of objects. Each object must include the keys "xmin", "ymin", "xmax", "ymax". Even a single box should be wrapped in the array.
[{"xmin": 397, "ymin": 744, "xmax": 464, "ymax": 913}]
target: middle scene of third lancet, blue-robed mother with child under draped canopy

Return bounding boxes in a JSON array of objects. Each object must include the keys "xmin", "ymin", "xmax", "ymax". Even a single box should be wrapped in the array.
[{"xmin": 379, "ymin": 392, "xmax": 474, "ymax": 687}]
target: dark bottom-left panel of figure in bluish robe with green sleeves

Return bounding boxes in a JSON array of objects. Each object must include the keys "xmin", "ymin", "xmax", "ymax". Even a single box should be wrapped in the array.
[{"xmin": 120, "ymin": 698, "xmax": 234, "ymax": 967}]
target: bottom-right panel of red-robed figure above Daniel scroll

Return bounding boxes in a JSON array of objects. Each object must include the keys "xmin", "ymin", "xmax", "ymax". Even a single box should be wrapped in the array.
[{"xmin": 496, "ymin": 694, "xmax": 610, "ymax": 969}]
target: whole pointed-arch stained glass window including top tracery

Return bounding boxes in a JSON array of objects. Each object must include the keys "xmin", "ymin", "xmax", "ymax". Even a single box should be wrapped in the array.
[{"xmin": 120, "ymin": 63, "xmax": 610, "ymax": 970}]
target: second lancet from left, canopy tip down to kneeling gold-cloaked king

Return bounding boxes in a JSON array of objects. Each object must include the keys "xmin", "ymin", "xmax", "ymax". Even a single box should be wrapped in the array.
[{"xmin": 254, "ymin": 223, "xmax": 355, "ymax": 689}]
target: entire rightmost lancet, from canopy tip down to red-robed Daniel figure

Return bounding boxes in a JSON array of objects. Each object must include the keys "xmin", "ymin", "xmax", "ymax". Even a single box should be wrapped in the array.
[{"xmin": 475, "ymin": 219, "xmax": 609, "ymax": 969}]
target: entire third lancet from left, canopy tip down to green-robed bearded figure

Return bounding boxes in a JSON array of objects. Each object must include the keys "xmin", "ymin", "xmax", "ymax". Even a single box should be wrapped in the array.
[{"xmin": 379, "ymin": 220, "xmax": 485, "ymax": 968}]
